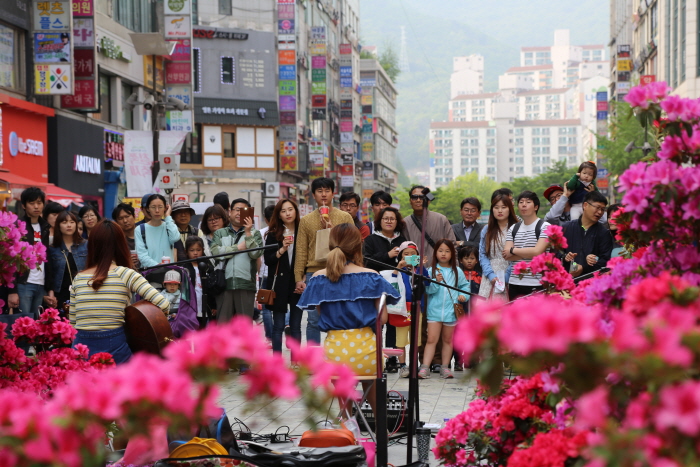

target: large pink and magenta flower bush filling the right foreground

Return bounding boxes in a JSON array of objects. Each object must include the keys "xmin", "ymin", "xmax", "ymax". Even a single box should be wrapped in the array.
[{"xmin": 436, "ymin": 83, "xmax": 700, "ymax": 467}]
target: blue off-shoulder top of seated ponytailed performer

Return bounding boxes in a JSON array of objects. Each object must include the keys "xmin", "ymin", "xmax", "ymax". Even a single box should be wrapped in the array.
[{"xmin": 297, "ymin": 272, "xmax": 400, "ymax": 332}]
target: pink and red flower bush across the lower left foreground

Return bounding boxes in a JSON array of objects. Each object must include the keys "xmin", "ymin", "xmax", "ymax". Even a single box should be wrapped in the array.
[{"xmin": 0, "ymin": 310, "xmax": 356, "ymax": 467}]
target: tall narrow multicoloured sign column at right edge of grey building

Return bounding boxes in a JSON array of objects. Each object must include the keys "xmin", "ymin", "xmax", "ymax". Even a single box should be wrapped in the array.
[{"xmin": 277, "ymin": 0, "xmax": 299, "ymax": 171}]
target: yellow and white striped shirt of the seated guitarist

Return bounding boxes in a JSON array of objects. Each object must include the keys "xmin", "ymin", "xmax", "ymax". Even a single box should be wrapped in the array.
[{"xmin": 69, "ymin": 266, "xmax": 170, "ymax": 331}]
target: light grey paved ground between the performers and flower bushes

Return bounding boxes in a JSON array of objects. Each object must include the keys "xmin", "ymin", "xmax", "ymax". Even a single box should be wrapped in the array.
[{"xmin": 220, "ymin": 333, "xmax": 475, "ymax": 466}]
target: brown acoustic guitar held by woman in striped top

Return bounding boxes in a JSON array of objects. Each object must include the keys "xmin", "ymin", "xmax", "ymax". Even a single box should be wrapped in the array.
[{"xmin": 124, "ymin": 300, "xmax": 174, "ymax": 355}]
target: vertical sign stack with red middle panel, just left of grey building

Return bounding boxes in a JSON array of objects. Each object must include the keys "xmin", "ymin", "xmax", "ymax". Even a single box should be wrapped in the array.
[{"xmin": 165, "ymin": 0, "xmax": 194, "ymax": 132}]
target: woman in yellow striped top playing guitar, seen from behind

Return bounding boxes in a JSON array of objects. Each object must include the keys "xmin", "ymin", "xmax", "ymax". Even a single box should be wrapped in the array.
[{"xmin": 70, "ymin": 219, "xmax": 170, "ymax": 364}]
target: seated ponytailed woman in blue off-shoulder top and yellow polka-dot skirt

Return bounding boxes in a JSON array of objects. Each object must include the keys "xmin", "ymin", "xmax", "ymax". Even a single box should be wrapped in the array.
[{"xmin": 297, "ymin": 224, "xmax": 400, "ymax": 416}]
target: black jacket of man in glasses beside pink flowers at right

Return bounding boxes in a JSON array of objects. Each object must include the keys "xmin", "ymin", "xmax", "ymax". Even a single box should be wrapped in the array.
[{"xmin": 559, "ymin": 218, "xmax": 613, "ymax": 274}]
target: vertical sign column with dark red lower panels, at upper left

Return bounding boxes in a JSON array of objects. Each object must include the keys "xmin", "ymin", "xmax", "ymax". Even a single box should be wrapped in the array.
[{"xmin": 61, "ymin": 0, "xmax": 99, "ymax": 110}]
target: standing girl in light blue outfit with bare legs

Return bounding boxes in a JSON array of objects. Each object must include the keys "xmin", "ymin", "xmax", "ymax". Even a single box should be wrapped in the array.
[{"xmin": 418, "ymin": 238, "xmax": 471, "ymax": 379}]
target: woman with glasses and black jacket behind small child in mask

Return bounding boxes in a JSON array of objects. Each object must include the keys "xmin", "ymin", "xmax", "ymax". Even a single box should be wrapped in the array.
[{"xmin": 362, "ymin": 207, "xmax": 406, "ymax": 373}]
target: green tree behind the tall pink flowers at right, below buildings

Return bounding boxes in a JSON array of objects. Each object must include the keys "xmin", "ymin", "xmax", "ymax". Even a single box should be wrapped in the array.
[{"xmin": 598, "ymin": 101, "xmax": 658, "ymax": 177}]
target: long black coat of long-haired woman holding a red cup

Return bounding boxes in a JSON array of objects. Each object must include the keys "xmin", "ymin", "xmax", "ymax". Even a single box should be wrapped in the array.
[{"xmin": 263, "ymin": 227, "xmax": 301, "ymax": 313}]
